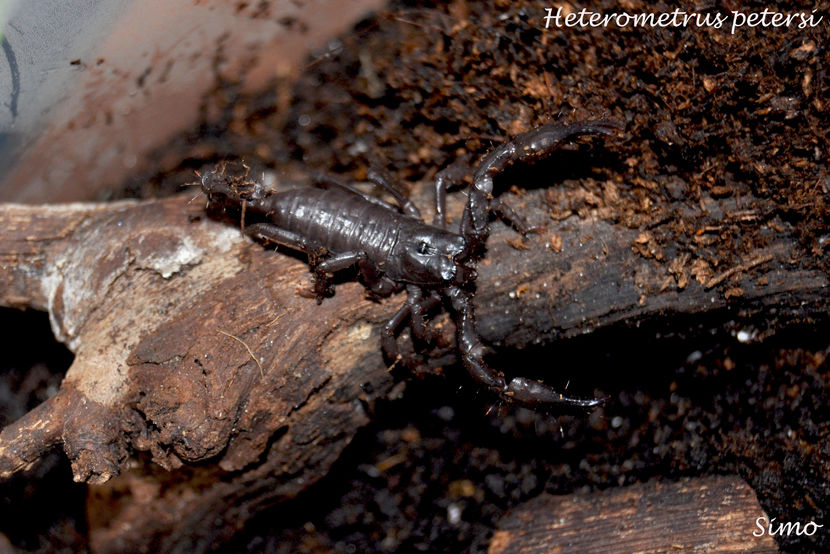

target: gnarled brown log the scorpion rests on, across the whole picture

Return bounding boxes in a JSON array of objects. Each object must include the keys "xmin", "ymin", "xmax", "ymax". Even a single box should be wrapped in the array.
[{"xmin": 0, "ymin": 184, "xmax": 830, "ymax": 549}]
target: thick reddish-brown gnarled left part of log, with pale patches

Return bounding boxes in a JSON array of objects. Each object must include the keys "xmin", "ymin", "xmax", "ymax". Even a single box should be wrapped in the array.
[{"xmin": 0, "ymin": 196, "xmax": 397, "ymax": 551}]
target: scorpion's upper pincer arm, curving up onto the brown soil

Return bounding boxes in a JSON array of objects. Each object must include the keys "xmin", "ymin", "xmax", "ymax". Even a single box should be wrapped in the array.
[{"xmin": 461, "ymin": 121, "xmax": 619, "ymax": 249}]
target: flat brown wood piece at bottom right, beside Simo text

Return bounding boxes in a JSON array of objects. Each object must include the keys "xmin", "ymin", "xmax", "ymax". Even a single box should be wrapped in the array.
[{"xmin": 490, "ymin": 476, "xmax": 778, "ymax": 554}]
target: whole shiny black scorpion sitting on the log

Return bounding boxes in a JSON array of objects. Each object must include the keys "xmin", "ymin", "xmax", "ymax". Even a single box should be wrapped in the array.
[{"xmin": 201, "ymin": 121, "xmax": 618, "ymax": 409}]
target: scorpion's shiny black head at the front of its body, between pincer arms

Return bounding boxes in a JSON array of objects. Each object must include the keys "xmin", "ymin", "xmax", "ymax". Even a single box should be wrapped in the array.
[{"xmin": 396, "ymin": 226, "xmax": 475, "ymax": 286}]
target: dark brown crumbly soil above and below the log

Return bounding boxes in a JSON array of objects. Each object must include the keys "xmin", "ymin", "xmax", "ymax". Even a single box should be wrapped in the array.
[{"xmin": 2, "ymin": 0, "xmax": 830, "ymax": 552}]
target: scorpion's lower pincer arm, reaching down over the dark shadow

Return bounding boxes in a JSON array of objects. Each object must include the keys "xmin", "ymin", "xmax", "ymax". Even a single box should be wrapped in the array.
[{"xmin": 447, "ymin": 287, "xmax": 605, "ymax": 409}]
